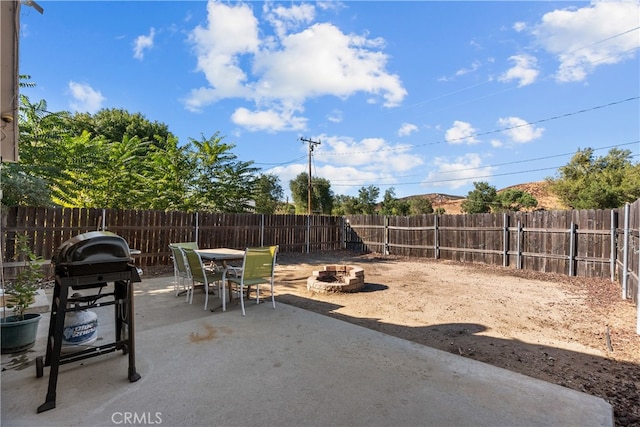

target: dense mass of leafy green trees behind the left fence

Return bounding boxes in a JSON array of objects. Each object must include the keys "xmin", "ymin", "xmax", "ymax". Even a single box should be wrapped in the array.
[{"xmin": 12, "ymin": 85, "xmax": 272, "ymax": 212}]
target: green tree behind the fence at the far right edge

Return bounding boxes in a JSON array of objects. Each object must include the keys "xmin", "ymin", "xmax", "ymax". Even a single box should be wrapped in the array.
[{"xmin": 548, "ymin": 148, "xmax": 640, "ymax": 209}]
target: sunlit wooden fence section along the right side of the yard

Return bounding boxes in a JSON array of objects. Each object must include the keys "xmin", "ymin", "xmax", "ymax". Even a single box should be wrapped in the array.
[{"xmin": 345, "ymin": 200, "xmax": 640, "ymax": 303}]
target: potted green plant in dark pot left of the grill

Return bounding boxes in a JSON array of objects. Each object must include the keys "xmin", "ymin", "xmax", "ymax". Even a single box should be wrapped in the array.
[{"xmin": 0, "ymin": 236, "xmax": 44, "ymax": 354}]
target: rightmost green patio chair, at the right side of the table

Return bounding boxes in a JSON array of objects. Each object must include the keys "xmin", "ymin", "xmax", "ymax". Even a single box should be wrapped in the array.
[{"xmin": 222, "ymin": 246, "xmax": 278, "ymax": 316}]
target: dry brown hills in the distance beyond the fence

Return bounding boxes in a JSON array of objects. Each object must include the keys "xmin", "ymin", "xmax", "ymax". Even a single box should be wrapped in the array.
[{"xmin": 403, "ymin": 181, "xmax": 567, "ymax": 214}]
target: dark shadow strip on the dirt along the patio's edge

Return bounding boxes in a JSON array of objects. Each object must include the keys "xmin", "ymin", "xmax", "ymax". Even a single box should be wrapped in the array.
[{"xmin": 276, "ymin": 292, "xmax": 640, "ymax": 426}]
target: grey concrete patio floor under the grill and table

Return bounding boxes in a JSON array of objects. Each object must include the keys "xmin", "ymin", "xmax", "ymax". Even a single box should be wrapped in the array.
[{"xmin": 1, "ymin": 276, "xmax": 613, "ymax": 427}]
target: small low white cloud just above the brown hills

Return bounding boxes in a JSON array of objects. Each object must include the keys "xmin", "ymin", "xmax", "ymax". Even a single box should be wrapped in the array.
[{"xmin": 422, "ymin": 153, "xmax": 495, "ymax": 189}]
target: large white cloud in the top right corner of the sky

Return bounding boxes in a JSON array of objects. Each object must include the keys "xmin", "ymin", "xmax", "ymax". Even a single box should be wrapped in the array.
[{"xmin": 532, "ymin": 1, "xmax": 640, "ymax": 82}]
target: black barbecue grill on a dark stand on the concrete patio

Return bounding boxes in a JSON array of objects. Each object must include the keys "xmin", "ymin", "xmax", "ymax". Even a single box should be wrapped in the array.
[{"xmin": 36, "ymin": 231, "xmax": 141, "ymax": 413}]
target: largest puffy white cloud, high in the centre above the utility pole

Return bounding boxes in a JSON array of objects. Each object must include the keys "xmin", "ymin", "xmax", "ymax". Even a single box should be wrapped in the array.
[{"xmin": 254, "ymin": 23, "xmax": 406, "ymax": 106}]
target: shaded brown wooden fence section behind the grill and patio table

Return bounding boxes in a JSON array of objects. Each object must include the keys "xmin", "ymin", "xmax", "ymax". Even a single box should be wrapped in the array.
[{"xmin": 2, "ymin": 207, "xmax": 344, "ymax": 270}]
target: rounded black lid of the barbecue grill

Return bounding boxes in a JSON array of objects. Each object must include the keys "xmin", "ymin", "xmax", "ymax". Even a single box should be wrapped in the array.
[{"xmin": 51, "ymin": 231, "xmax": 132, "ymax": 265}]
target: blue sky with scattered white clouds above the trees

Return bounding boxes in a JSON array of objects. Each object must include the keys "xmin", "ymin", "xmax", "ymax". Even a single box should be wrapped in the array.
[{"xmin": 20, "ymin": 0, "xmax": 640, "ymax": 201}]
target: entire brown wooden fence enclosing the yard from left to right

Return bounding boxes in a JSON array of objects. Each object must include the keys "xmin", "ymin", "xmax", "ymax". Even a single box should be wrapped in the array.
[{"xmin": 1, "ymin": 200, "xmax": 640, "ymax": 320}]
